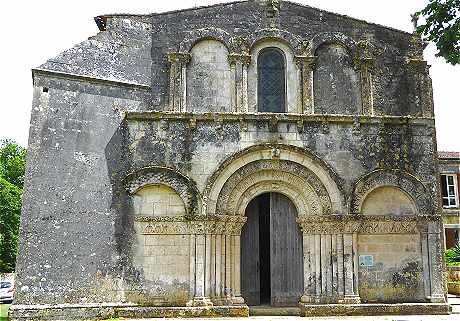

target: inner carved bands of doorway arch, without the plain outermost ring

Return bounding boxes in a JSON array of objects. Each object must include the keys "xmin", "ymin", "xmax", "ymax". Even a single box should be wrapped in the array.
[{"xmin": 217, "ymin": 160, "xmax": 331, "ymax": 215}]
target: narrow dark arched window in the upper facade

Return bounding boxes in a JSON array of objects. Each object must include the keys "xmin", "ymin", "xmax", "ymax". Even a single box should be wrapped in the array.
[{"xmin": 257, "ymin": 48, "xmax": 286, "ymax": 113}]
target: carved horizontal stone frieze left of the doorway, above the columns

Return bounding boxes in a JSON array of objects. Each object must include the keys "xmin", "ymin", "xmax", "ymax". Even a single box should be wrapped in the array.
[{"xmin": 134, "ymin": 215, "xmax": 247, "ymax": 235}]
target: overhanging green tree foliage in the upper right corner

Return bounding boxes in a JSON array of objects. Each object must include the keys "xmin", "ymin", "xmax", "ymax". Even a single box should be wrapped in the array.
[{"xmin": 415, "ymin": 0, "xmax": 460, "ymax": 65}]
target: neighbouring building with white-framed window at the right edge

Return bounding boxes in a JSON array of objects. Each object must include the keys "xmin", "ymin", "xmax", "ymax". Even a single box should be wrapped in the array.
[{"xmin": 438, "ymin": 152, "xmax": 460, "ymax": 249}]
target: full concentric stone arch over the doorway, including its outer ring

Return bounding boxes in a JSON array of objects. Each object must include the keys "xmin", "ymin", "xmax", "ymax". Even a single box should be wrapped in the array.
[{"xmin": 203, "ymin": 144, "xmax": 345, "ymax": 215}]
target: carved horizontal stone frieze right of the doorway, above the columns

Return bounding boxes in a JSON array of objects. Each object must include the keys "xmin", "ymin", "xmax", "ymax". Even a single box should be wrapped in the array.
[{"xmin": 297, "ymin": 215, "xmax": 441, "ymax": 234}]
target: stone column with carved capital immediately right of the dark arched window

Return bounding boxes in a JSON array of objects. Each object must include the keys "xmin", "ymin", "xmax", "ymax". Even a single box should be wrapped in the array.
[{"xmin": 294, "ymin": 56, "xmax": 316, "ymax": 114}]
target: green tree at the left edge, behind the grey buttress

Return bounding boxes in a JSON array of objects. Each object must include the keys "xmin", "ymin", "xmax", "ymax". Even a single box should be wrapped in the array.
[{"xmin": 0, "ymin": 140, "xmax": 26, "ymax": 272}]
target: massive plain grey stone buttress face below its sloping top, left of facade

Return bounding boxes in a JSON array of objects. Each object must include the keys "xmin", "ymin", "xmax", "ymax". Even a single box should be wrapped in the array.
[{"xmin": 15, "ymin": 72, "xmax": 150, "ymax": 304}]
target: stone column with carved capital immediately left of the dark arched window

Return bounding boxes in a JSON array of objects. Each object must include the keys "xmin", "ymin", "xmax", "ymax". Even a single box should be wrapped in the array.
[{"xmin": 228, "ymin": 53, "xmax": 251, "ymax": 113}]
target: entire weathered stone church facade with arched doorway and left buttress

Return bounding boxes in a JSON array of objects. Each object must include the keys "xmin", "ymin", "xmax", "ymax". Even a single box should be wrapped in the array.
[{"xmin": 11, "ymin": 0, "xmax": 448, "ymax": 320}]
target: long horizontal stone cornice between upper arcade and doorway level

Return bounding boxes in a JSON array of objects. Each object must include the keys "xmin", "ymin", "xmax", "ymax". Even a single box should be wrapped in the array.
[{"xmin": 125, "ymin": 111, "xmax": 434, "ymax": 127}]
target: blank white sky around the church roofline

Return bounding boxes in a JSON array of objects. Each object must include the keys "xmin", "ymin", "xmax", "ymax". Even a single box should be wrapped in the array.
[{"xmin": 0, "ymin": 0, "xmax": 460, "ymax": 151}]
